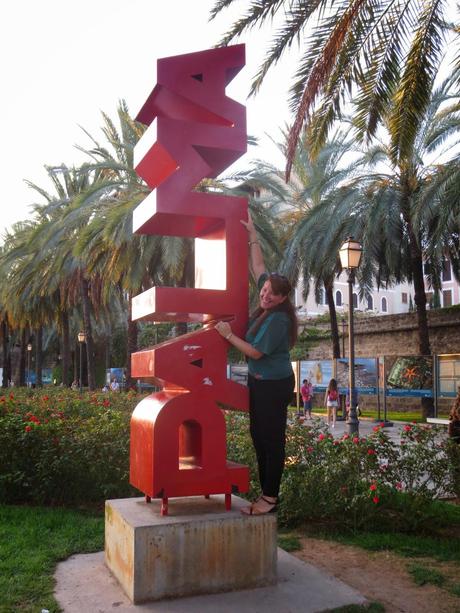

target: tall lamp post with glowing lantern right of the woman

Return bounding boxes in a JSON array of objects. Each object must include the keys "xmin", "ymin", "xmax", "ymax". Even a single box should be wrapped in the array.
[{"xmin": 339, "ymin": 236, "xmax": 363, "ymax": 436}]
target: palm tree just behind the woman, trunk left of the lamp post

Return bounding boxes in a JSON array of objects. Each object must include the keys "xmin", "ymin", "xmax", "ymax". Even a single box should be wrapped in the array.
[{"xmin": 237, "ymin": 131, "xmax": 358, "ymax": 358}]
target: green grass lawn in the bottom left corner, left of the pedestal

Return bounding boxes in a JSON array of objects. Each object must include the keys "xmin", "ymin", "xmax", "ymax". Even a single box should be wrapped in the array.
[{"xmin": 0, "ymin": 505, "xmax": 104, "ymax": 613}]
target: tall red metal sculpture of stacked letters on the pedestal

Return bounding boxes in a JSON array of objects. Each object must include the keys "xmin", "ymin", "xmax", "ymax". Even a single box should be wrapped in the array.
[{"xmin": 130, "ymin": 45, "xmax": 249, "ymax": 514}]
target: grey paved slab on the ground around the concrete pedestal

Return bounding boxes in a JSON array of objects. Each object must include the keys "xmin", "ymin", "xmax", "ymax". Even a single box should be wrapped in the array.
[{"xmin": 55, "ymin": 549, "xmax": 366, "ymax": 613}]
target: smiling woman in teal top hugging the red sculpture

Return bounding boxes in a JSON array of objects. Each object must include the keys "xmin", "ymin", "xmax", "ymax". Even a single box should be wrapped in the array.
[{"xmin": 216, "ymin": 216, "xmax": 297, "ymax": 515}]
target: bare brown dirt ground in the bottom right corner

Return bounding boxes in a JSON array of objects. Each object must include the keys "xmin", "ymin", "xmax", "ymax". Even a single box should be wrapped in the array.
[{"xmin": 292, "ymin": 538, "xmax": 460, "ymax": 613}]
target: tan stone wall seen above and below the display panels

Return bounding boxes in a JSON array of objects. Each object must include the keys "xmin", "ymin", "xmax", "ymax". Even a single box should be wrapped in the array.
[{"xmin": 306, "ymin": 308, "xmax": 460, "ymax": 412}]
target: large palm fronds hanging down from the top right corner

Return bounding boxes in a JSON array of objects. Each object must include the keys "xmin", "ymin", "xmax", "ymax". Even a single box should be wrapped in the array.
[{"xmin": 211, "ymin": 0, "xmax": 458, "ymax": 175}]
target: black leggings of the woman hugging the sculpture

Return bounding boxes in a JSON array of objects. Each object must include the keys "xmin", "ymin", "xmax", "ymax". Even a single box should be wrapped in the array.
[{"xmin": 248, "ymin": 375, "xmax": 294, "ymax": 498}]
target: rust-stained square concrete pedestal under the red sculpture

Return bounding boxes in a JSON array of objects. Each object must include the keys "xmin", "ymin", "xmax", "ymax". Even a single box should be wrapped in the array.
[{"xmin": 105, "ymin": 495, "xmax": 277, "ymax": 604}]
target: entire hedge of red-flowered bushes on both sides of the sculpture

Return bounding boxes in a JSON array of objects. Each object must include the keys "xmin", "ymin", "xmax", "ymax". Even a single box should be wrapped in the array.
[{"xmin": 0, "ymin": 388, "xmax": 460, "ymax": 532}]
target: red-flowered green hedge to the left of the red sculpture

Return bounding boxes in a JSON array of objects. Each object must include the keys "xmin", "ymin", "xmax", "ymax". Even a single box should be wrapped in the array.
[{"xmin": 0, "ymin": 388, "xmax": 137, "ymax": 504}]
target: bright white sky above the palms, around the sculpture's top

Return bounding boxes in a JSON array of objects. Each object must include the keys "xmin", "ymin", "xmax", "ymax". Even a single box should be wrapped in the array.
[{"xmin": 0, "ymin": 0, "xmax": 289, "ymax": 236}]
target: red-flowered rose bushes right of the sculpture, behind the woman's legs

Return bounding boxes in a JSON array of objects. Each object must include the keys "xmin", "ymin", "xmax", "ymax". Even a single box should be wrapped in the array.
[{"xmin": 228, "ymin": 416, "xmax": 460, "ymax": 531}]
